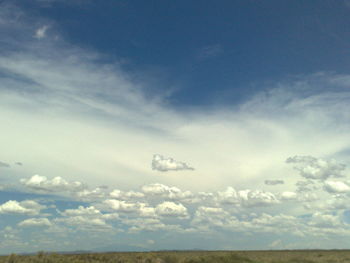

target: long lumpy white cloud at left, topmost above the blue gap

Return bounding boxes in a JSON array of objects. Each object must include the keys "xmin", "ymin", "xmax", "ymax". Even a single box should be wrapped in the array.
[{"xmin": 21, "ymin": 175, "xmax": 85, "ymax": 192}]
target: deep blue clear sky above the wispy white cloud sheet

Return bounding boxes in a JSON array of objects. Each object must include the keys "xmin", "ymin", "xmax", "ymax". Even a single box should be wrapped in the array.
[{"xmin": 17, "ymin": 0, "xmax": 350, "ymax": 106}]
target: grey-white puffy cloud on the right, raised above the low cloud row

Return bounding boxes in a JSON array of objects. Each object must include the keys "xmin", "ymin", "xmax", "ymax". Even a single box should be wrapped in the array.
[{"xmin": 286, "ymin": 155, "xmax": 345, "ymax": 180}]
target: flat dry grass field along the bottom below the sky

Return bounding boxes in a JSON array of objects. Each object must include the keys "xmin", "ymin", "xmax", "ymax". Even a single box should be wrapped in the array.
[{"xmin": 0, "ymin": 250, "xmax": 350, "ymax": 263}]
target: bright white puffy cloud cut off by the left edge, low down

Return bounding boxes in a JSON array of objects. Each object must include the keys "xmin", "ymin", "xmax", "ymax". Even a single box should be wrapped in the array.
[{"xmin": 0, "ymin": 200, "xmax": 45, "ymax": 215}]
